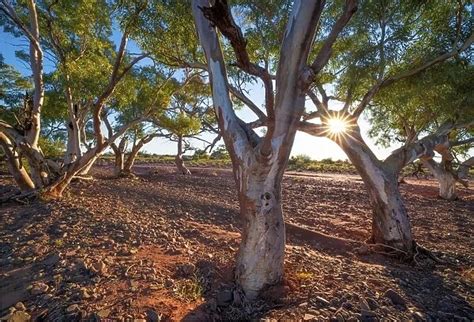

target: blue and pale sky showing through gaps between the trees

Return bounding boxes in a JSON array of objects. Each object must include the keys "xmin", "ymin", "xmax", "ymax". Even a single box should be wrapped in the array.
[{"xmin": 0, "ymin": 30, "xmax": 395, "ymax": 160}]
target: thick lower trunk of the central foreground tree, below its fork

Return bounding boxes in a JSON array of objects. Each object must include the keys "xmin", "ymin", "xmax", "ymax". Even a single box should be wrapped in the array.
[{"xmin": 236, "ymin": 167, "xmax": 285, "ymax": 298}]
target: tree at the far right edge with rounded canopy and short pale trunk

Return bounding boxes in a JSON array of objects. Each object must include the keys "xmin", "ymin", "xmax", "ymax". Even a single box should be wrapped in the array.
[{"xmin": 369, "ymin": 61, "xmax": 474, "ymax": 200}]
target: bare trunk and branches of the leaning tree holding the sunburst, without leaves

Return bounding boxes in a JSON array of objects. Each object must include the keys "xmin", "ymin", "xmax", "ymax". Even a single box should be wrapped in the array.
[{"xmin": 300, "ymin": 31, "xmax": 474, "ymax": 257}]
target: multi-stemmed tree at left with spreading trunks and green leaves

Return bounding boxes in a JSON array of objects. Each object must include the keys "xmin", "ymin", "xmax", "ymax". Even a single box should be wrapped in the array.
[{"xmin": 0, "ymin": 0, "xmax": 152, "ymax": 197}]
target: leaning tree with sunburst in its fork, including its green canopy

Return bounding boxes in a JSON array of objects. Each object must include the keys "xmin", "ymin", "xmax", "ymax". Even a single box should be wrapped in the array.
[{"xmin": 301, "ymin": 1, "xmax": 474, "ymax": 252}]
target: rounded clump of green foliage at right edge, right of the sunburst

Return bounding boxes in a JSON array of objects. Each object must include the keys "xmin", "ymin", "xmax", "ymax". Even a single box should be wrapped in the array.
[{"xmin": 369, "ymin": 60, "xmax": 474, "ymax": 146}]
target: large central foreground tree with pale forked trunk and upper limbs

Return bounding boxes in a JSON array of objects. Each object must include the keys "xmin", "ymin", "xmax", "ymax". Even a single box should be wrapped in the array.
[{"xmin": 192, "ymin": 0, "xmax": 356, "ymax": 298}]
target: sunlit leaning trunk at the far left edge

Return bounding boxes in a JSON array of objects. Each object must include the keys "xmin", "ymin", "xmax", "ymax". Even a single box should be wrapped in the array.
[{"xmin": 0, "ymin": 132, "xmax": 35, "ymax": 191}]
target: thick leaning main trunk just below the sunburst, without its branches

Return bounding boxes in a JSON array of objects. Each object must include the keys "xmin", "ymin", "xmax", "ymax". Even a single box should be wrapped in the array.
[{"xmin": 336, "ymin": 133, "xmax": 413, "ymax": 254}]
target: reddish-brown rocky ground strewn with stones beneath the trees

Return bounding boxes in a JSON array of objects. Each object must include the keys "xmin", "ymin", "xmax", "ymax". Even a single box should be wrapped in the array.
[{"xmin": 0, "ymin": 165, "xmax": 474, "ymax": 321}]
